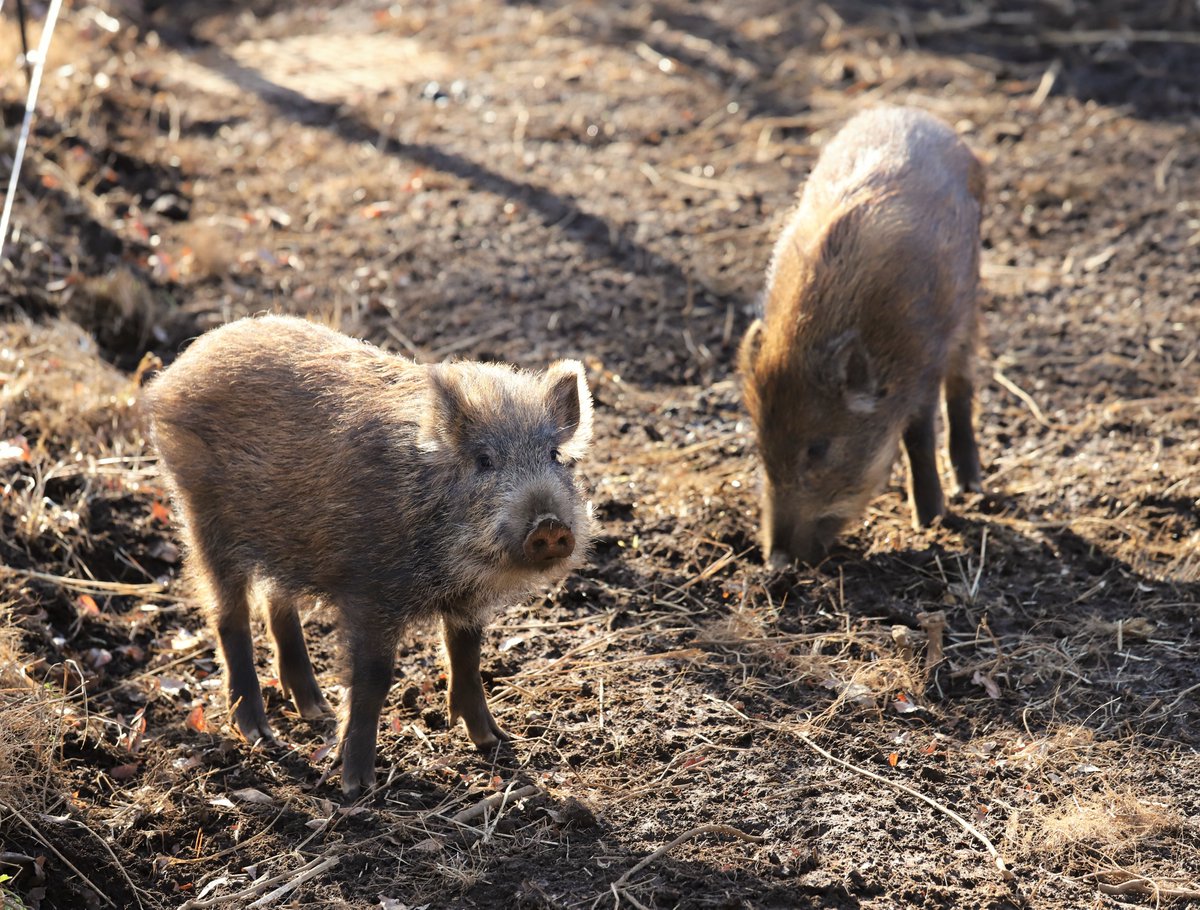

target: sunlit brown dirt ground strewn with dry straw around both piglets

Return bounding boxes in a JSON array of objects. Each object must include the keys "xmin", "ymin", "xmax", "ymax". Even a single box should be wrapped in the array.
[{"xmin": 0, "ymin": 0, "xmax": 1200, "ymax": 910}]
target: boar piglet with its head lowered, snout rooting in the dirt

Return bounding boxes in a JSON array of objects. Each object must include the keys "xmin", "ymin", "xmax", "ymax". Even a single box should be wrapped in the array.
[{"xmin": 738, "ymin": 108, "xmax": 984, "ymax": 565}]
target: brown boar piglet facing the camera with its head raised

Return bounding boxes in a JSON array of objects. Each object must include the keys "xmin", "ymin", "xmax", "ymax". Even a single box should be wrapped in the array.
[{"xmin": 146, "ymin": 317, "xmax": 592, "ymax": 796}]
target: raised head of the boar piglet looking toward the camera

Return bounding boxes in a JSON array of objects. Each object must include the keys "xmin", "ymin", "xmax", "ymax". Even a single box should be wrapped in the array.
[{"xmin": 421, "ymin": 360, "xmax": 592, "ymax": 587}]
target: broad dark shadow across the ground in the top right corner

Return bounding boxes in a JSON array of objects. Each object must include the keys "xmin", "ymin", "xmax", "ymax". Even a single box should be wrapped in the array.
[{"xmin": 513, "ymin": 0, "xmax": 1200, "ymax": 119}]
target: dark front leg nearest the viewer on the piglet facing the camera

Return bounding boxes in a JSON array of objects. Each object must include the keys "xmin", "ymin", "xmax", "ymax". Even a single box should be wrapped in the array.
[{"xmin": 340, "ymin": 624, "xmax": 400, "ymax": 798}]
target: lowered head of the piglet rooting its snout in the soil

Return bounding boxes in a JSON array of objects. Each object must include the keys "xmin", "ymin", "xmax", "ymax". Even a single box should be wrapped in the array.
[{"xmin": 738, "ymin": 321, "xmax": 899, "ymax": 565}]
